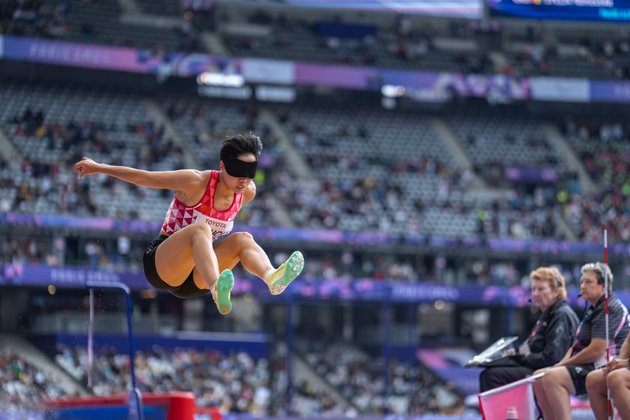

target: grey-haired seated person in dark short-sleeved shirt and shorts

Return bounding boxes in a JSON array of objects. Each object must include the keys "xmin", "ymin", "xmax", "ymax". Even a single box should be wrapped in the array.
[{"xmin": 534, "ymin": 263, "xmax": 630, "ymax": 420}]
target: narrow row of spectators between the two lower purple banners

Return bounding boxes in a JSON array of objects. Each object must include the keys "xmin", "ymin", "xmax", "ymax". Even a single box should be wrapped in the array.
[{"xmin": 6, "ymin": 231, "xmax": 627, "ymax": 289}]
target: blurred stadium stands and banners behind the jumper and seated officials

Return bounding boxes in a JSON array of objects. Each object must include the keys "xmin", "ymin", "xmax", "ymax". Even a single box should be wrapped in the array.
[{"xmin": 0, "ymin": 0, "xmax": 630, "ymax": 418}]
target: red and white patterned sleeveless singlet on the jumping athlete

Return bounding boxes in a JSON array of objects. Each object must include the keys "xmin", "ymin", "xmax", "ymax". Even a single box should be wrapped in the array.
[{"xmin": 162, "ymin": 171, "xmax": 243, "ymax": 239}]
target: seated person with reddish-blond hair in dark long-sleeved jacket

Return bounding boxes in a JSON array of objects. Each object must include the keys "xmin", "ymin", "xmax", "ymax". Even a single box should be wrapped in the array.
[{"xmin": 479, "ymin": 267, "xmax": 578, "ymax": 392}]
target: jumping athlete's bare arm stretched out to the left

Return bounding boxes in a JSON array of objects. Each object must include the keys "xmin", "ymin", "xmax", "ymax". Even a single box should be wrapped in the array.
[{"xmin": 74, "ymin": 157, "xmax": 204, "ymax": 191}]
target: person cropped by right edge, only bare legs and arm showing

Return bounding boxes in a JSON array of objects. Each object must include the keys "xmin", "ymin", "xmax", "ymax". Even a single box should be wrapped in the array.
[{"xmin": 586, "ymin": 334, "xmax": 630, "ymax": 420}]
